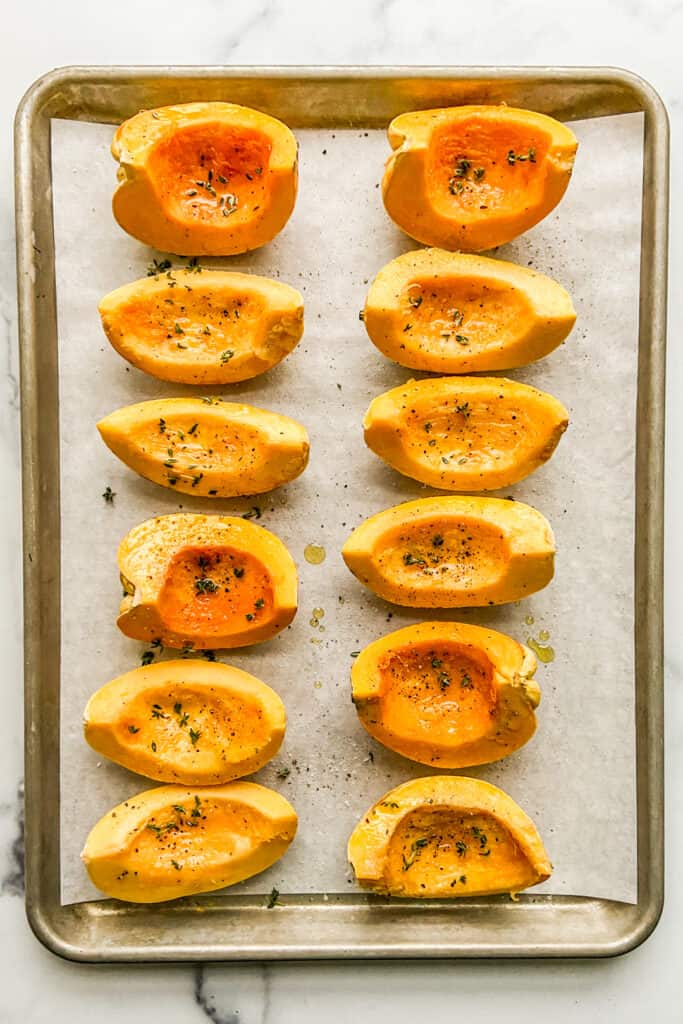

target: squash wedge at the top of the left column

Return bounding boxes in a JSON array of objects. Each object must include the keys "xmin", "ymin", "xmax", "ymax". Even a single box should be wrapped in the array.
[{"xmin": 112, "ymin": 102, "xmax": 297, "ymax": 256}]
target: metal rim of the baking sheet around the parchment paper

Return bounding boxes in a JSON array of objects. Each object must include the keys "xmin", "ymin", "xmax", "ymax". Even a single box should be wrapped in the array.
[{"xmin": 15, "ymin": 67, "xmax": 669, "ymax": 963}]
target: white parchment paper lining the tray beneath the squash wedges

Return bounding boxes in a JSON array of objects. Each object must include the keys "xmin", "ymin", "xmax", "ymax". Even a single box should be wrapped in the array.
[{"xmin": 52, "ymin": 115, "xmax": 642, "ymax": 903}]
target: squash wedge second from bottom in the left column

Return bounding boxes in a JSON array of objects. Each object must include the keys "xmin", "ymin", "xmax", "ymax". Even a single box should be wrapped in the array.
[{"xmin": 83, "ymin": 659, "xmax": 287, "ymax": 785}]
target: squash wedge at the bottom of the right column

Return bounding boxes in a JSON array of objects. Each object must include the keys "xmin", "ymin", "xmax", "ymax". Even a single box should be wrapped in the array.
[{"xmin": 348, "ymin": 775, "xmax": 552, "ymax": 899}]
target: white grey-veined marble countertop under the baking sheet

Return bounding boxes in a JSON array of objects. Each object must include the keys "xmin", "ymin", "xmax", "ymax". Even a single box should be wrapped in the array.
[{"xmin": 0, "ymin": 0, "xmax": 683, "ymax": 1024}]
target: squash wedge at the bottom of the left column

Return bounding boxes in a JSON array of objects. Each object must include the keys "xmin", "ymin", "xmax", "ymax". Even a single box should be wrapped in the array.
[{"xmin": 81, "ymin": 782, "xmax": 297, "ymax": 903}]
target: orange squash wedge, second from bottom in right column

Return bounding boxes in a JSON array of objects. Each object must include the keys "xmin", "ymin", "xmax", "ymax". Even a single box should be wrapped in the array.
[{"xmin": 351, "ymin": 623, "xmax": 541, "ymax": 768}]
